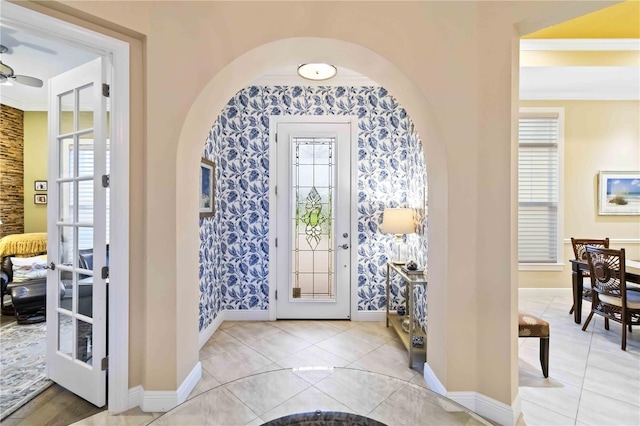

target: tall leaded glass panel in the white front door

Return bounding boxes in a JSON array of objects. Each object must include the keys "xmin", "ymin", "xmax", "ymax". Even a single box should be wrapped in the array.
[{"xmin": 291, "ymin": 137, "xmax": 335, "ymax": 300}]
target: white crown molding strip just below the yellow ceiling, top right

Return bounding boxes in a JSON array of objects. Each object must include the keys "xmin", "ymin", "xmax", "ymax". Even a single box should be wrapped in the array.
[{"xmin": 520, "ymin": 38, "xmax": 640, "ymax": 51}]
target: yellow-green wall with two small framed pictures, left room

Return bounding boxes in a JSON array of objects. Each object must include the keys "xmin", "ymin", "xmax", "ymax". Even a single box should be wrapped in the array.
[{"xmin": 24, "ymin": 111, "xmax": 48, "ymax": 232}]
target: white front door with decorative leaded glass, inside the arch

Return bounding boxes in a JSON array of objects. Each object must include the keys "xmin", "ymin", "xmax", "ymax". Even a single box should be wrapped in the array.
[{"xmin": 275, "ymin": 120, "xmax": 355, "ymax": 319}]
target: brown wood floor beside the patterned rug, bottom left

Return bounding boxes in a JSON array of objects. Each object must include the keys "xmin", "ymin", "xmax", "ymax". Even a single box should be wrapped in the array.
[{"xmin": 0, "ymin": 315, "xmax": 106, "ymax": 426}]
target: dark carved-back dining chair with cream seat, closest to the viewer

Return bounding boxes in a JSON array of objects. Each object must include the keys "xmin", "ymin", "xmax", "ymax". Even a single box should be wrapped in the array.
[{"xmin": 582, "ymin": 246, "xmax": 640, "ymax": 351}]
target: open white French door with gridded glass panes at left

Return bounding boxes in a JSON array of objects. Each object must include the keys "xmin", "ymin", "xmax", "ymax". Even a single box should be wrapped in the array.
[{"xmin": 47, "ymin": 58, "xmax": 108, "ymax": 407}]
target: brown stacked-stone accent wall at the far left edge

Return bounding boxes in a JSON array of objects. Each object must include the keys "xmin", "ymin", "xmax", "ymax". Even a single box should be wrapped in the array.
[{"xmin": 0, "ymin": 105, "xmax": 24, "ymax": 237}]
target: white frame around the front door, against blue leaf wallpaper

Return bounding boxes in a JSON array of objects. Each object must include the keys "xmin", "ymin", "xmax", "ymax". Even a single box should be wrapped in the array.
[{"xmin": 269, "ymin": 115, "xmax": 358, "ymax": 321}]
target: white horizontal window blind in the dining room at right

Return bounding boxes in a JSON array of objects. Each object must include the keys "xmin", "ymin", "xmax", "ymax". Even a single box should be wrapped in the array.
[{"xmin": 518, "ymin": 113, "xmax": 560, "ymax": 263}]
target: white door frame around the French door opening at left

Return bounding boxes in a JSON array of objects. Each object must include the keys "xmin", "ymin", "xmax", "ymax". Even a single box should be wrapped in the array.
[{"xmin": 0, "ymin": 1, "xmax": 130, "ymax": 414}]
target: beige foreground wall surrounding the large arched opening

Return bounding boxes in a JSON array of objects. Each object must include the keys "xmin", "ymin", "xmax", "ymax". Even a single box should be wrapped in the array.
[{"xmin": 21, "ymin": 1, "xmax": 616, "ymax": 416}]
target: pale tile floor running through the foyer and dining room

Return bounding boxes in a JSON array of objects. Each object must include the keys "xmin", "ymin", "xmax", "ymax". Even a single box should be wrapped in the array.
[{"xmin": 76, "ymin": 289, "xmax": 640, "ymax": 425}]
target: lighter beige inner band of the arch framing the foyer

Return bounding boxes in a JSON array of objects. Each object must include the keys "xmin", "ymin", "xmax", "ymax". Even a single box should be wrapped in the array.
[{"xmin": 176, "ymin": 38, "xmax": 447, "ymax": 364}]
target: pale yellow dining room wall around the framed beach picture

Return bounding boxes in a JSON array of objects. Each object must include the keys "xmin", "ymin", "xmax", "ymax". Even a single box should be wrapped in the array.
[{"xmin": 519, "ymin": 101, "xmax": 640, "ymax": 287}]
